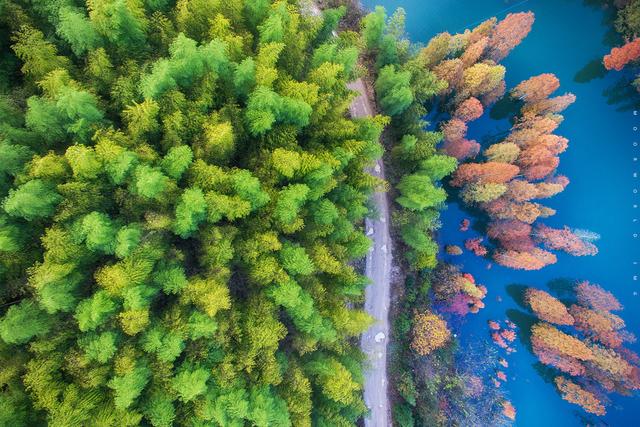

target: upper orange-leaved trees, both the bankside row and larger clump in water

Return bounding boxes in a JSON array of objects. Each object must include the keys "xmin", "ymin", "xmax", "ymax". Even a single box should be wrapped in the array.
[{"xmin": 442, "ymin": 28, "xmax": 597, "ymax": 270}]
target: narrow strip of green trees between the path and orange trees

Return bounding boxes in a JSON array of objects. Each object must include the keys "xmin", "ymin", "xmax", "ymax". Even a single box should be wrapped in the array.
[{"xmin": 362, "ymin": 7, "xmax": 450, "ymax": 269}]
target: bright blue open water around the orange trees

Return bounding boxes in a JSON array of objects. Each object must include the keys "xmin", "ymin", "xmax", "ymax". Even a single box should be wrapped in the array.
[{"xmin": 364, "ymin": 0, "xmax": 640, "ymax": 427}]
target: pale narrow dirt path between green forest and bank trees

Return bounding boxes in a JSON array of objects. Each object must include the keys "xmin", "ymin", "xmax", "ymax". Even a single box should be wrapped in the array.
[{"xmin": 348, "ymin": 79, "xmax": 391, "ymax": 427}]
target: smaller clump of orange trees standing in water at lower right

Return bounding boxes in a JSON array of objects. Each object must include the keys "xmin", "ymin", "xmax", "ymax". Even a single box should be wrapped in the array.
[{"xmin": 525, "ymin": 282, "xmax": 640, "ymax": 415}]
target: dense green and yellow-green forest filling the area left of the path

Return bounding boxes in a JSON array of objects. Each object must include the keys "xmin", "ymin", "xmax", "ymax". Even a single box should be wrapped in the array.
[{"xmin": 0, "ymin": 0, "xmax": 382, "ymax": 427}]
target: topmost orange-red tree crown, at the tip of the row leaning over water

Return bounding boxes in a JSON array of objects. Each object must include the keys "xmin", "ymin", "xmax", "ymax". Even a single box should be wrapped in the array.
[{"xmin": 489, "ymin": 12, "xmax": 535, "ymax": 62}]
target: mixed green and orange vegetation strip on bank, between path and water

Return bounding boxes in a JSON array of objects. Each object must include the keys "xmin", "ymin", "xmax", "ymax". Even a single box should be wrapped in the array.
[{"xmin": 363, "ymin": 7, "xmax": 533, "ymax": 426}]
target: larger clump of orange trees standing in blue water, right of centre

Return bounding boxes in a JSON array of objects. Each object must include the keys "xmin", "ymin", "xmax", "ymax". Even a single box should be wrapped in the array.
[{"xmin": 450, "ymin": 74, "xmax": 598, "ymax": 270}]
